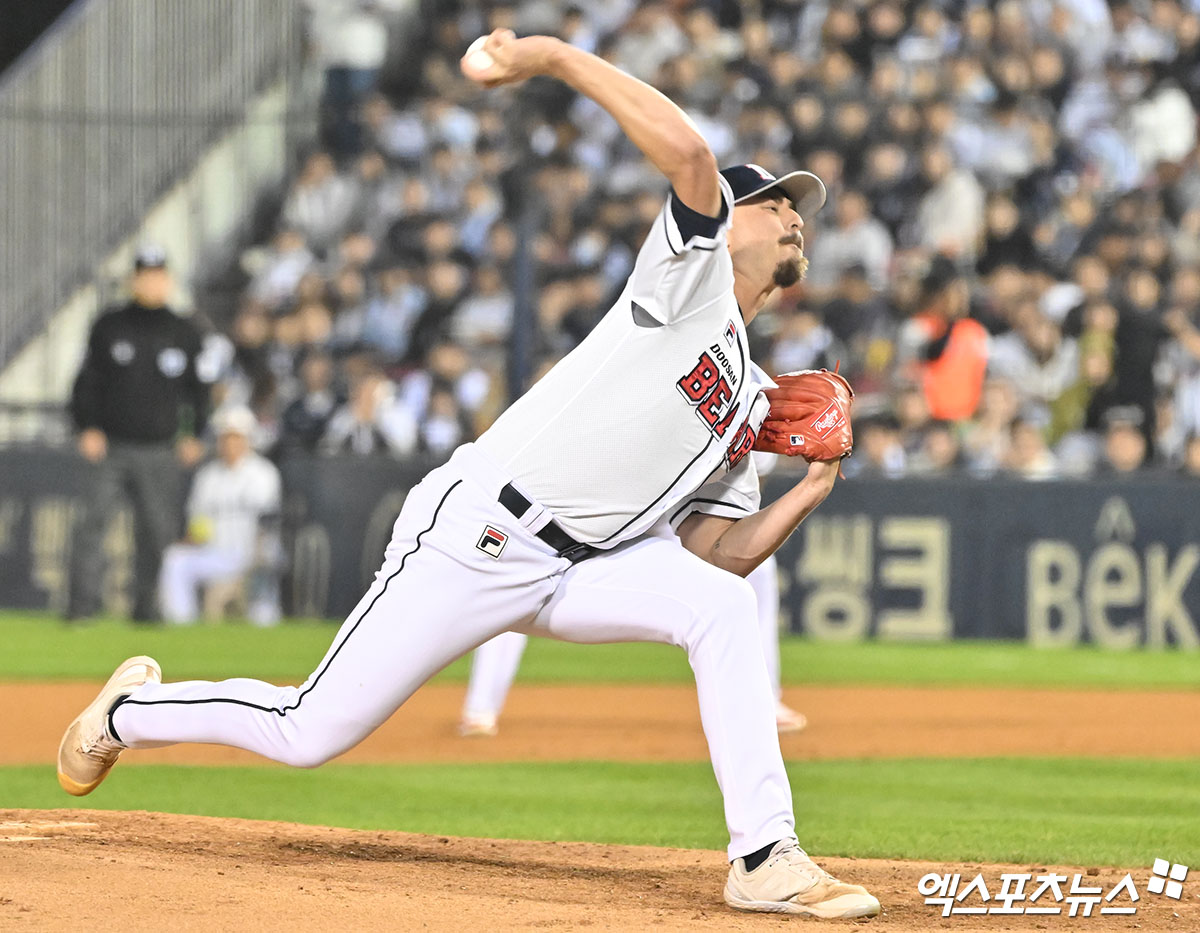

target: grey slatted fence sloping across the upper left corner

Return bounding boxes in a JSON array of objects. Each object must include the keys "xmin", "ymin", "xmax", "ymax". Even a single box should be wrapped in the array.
[{"xmin": 0, "ymin": 0, "xmax": 304, "ymax": 378}]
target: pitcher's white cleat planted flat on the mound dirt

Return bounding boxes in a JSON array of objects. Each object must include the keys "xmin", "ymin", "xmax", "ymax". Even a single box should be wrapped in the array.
[{"xmin": 725, "ymin": 839, "xmax": 880, "ymax": 920}]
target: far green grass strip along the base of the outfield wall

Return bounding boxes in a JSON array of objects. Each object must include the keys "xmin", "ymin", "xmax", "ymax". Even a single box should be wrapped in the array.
[{"xmin": 7, "ymin": 613, "xmax": 1200, "ymax": 690}]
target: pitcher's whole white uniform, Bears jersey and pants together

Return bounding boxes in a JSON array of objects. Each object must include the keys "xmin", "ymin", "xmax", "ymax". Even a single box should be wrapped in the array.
[{"xmin": 109, "ymin": 183, "xmax": 796, "ymax": 860}]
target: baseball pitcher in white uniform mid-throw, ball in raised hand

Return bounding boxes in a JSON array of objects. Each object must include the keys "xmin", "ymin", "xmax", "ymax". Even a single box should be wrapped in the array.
[{"xmin": 59, "ymin": 30, "xmax": 880, "ymax": 917}]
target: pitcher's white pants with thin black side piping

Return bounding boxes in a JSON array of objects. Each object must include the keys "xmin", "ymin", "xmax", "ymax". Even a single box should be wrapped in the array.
[{"xmin": 112, "ymin": 445, "xmax": 794, "ymax": 859}]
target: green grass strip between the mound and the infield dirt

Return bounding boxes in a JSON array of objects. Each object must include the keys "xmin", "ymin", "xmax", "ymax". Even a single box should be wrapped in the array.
[{"xmin": 0, "ymin": 758, "xmax": 1200, "ymax": 866}]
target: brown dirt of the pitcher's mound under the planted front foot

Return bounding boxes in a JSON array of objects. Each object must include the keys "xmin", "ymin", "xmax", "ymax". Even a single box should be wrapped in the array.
[{"xmin": 0, "ymin": 809, "xmax": 1200, "ymax": 933}]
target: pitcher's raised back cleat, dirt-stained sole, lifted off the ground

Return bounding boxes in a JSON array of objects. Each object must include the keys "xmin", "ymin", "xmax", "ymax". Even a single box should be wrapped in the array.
[{"xmin": 59, "ymin": 656, "xmax": 162, "ymax": 797}]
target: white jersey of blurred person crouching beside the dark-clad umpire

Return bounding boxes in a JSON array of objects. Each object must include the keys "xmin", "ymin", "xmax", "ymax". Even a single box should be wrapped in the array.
[{"xmin": 187, "ymin": 453, "xmax": 280, "ymax": 564}]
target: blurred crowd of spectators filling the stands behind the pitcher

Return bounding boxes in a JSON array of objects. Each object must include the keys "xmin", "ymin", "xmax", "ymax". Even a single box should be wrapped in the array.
[{"xmin": 199, "ymin": 0, "xmax": 1200, "ymax": 480}]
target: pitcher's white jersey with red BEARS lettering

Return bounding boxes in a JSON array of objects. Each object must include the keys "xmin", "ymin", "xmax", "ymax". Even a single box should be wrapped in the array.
[{"xmin": 476, "ymin": 172, "xmax": 774, "ymax": 548}]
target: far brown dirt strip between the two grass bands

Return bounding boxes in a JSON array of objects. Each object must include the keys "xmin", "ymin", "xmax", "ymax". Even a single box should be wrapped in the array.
[{"xmin": 0, "ymin": 684, "xmax": 1200, "ymax": 768}]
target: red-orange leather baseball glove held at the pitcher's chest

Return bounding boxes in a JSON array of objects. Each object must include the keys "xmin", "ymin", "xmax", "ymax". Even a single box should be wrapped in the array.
[{"xmin": 754, "ymin": 369, "xmax": 854, "ymax": 463}]
